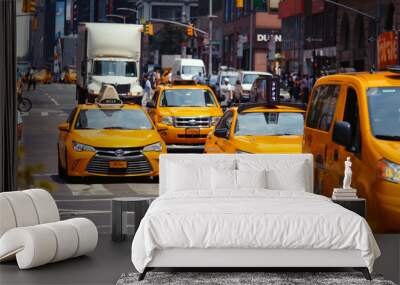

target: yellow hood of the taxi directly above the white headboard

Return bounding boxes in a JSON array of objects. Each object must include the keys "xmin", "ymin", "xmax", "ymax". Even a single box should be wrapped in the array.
[{"xmin": 235, "ymin": 136, "xmax": 303, "ymax": 153}]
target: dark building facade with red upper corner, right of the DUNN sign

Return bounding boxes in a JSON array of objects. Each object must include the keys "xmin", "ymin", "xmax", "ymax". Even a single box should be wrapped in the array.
[{"xmin": 279, "ymin": 0, "xmax": 400, "ymax": 76}]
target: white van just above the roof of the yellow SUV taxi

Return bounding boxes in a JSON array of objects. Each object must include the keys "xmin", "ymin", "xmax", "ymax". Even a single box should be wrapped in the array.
[{"xmin": 172, "ymin": 58, "xmax": 205, "ymax": 80}]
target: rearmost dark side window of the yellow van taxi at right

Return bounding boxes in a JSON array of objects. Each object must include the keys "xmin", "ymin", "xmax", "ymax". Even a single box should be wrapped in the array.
[{"xmin": 307, "ymin": 85, "xmax": 340, "ymax": 132}]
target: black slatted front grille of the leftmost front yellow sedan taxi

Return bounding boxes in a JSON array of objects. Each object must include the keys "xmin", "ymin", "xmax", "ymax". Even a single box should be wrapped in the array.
[{"xmin": 86, "ymin": 148, "xmax": 153, "ymax": 175}]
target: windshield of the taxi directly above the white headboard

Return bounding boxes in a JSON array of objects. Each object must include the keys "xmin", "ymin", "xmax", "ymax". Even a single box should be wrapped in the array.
[{"xmin": 235, "ymin": 112, "xmax": 304, "ymax": 136}]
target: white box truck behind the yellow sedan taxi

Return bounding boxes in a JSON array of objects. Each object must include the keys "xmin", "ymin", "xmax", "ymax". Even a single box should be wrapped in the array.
[{"xmin": 76, "ymin": 23, "xmax": 143, "ymax": 104}]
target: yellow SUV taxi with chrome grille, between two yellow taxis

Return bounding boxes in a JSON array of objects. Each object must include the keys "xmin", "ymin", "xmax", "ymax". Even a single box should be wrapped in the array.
[{"xmin": 146, "ymin": 80, "xmax": 223, "ymax": 148}]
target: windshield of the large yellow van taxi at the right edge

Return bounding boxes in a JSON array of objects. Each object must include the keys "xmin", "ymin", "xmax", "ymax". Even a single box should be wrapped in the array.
[{"xmin": 367, "ymin": 87, "xmax": 400, "ymax": 141}]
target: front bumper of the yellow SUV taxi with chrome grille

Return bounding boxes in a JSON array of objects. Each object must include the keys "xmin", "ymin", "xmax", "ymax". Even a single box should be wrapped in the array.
[{"xmin": 157, "ymin": 124, "xmax": 214, "ymax": 146}]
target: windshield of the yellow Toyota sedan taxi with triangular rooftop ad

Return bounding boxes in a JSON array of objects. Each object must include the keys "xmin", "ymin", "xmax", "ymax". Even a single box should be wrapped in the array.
[{"xmin": 75, "ymin": 109, "xmax": 153, "ymax": 130}]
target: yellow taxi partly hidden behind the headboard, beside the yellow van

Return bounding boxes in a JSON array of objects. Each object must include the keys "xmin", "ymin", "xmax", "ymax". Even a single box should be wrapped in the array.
[{"xmin": 204, "ymin": 103, "xmax": 304, "ymax": 153}]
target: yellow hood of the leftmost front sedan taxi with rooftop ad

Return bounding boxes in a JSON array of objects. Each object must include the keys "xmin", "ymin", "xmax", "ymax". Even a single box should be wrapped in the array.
[{"xmin": 71, "ymin": 130, "xmax": 161, "ymax": 147}]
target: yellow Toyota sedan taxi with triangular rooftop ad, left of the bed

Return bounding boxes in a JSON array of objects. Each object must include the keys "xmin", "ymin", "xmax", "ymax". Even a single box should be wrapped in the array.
[{"xmin": 58, "ymin": 86, "xmax": 166, "ymax": 178}]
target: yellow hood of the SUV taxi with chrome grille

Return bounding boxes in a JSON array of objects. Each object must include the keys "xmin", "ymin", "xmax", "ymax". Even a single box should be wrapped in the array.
[{"xmin": 160, "ymin": 106, "xmax": 223, "ymax": 117}]
